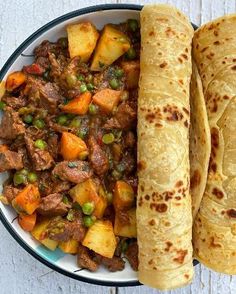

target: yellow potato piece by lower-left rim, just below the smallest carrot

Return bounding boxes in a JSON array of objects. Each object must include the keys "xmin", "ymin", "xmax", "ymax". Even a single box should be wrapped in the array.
[{"xmin": 31, "ymin": 219, "xmax": 58, "ymax": 251}]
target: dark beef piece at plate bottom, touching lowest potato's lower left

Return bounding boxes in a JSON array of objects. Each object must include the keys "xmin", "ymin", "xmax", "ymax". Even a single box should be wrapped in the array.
[{"xmin": 77, "ymin": 245, "xmax": 98, "ymax": 272}]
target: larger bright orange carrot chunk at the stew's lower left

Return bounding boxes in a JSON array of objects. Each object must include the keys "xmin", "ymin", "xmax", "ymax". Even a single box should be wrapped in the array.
[{"xmin": 12, "ymin": 184, "xmax": 40, "ymax": 214}]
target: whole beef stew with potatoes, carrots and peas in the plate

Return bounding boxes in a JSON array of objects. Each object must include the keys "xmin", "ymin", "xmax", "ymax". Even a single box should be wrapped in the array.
[{"xmin": 0, "ymin": 19, "xmax": 140, "ymax": 271}]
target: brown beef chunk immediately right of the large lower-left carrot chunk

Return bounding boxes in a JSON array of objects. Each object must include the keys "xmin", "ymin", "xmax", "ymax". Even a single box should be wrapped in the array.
[{"xmin": 37, "ymin": 193, "xmax": 70, "ymax": 216}]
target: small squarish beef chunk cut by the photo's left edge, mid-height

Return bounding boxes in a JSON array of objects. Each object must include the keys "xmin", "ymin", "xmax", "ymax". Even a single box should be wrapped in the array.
[{"xmin": 0, "ymin": 150, "xmax": 23, "ymax": 172}]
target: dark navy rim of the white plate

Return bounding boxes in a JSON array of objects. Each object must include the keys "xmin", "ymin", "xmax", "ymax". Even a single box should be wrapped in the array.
[{"xmin": 0, "ymin": 3, "xmax": 198, "ymax": 287}]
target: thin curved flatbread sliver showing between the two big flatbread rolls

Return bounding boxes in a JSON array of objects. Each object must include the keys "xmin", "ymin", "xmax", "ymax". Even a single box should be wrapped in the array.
[{"xmin": 189, "ymin": 61, "xmax": 211, "ymax": 219}]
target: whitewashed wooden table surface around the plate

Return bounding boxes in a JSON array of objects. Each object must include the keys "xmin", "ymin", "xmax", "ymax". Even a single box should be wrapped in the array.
[{"xmin": 0, "ymin": 0, "xmax": 236, "ymax": 294}]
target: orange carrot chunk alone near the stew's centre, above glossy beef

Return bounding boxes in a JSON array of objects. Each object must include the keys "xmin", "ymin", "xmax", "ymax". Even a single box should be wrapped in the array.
[{"xmin": 61, "ymin": 132, "xmax": 88, "ymax": 160}]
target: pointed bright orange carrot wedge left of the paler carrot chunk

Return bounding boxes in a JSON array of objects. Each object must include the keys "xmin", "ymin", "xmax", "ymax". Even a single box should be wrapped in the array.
[{"xmin": 61, "ymin": 92, "xmax": 92, "ymax": 114}]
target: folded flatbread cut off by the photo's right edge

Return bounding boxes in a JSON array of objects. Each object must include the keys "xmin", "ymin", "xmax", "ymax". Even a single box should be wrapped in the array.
[{"xmin": 193, "ymin": 15, "xmax": 236, "ymax": 274}]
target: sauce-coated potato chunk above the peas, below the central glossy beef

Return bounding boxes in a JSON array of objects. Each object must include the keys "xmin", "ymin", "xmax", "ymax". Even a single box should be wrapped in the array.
[{"xmin": 69, "ymin": 179, "xmax": 107, "ymax": 218}]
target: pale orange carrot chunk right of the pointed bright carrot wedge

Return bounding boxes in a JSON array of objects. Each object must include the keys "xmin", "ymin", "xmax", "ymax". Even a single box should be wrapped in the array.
[{"xmin": 93, "ymin": 89, "xmax": 121, "ymax": 113}]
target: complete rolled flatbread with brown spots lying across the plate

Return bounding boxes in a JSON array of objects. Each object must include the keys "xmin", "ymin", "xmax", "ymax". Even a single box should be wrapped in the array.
[{"xmin": 137, "ymin": 5, "xmax": 193, "ymax": 290}]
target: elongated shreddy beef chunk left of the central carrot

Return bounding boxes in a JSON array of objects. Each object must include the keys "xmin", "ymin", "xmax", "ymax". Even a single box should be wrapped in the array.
[{"xmin": 25, "ymin": 136, "xmax": 54, "ymax": 171}]
